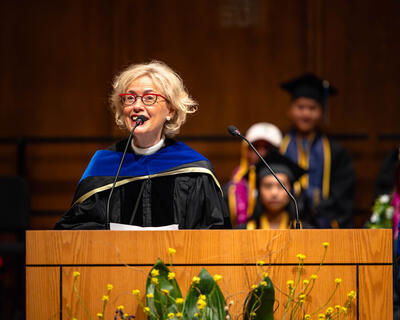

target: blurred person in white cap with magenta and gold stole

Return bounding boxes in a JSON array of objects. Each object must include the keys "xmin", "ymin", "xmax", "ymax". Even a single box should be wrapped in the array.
[{"xmin": 224, "ymin": 122, "xmax": 282, "ymax": 225}]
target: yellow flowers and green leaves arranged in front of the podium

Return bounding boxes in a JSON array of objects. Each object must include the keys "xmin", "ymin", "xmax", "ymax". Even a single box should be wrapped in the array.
[{"xmin": 67, "ymin": 242, "xmax": 356, "ymax": 320}]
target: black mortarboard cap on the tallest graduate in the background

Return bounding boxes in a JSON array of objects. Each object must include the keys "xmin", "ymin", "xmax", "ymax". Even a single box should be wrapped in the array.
[{"xmin": 281, "ymin": 73, "xmax": 337, "ymax": 106}]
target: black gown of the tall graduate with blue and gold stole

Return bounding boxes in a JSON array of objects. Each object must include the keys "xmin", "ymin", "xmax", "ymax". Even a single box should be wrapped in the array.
[{"xmin": 282, "ymin": 132, "xmax": 355, "ymax": 228}]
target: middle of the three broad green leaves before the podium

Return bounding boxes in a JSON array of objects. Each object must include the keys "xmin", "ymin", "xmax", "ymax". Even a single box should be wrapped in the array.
[{"xmin": 183, "ymin": 268, "xmax": 226, "ymax": 320}]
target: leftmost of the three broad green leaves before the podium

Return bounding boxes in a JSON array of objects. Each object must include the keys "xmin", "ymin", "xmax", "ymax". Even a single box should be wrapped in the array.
[{"xmin": 146, "ymin": 259, "xmax": 182, "ymax": 320}]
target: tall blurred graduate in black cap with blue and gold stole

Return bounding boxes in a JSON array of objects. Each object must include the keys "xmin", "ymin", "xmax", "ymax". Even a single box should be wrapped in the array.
[{"xmin": 280, "ymin": 74, "xmax": 355, "ymax": 228}]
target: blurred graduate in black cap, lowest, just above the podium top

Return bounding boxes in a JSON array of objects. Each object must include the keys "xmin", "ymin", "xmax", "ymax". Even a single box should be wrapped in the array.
[{"xmin": 246, "ymin": 151, "xmax": 305, "ymax": 230}]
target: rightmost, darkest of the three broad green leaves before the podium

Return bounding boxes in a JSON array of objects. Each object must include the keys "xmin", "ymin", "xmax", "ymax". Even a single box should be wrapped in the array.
[{"xmin": 243, "ymin": 277, "xmax": 275, "ymax": 320}]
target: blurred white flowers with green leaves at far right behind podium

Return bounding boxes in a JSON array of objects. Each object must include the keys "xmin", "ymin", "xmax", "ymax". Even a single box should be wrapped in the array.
[{"xmin": 367, "ymin": 194, "xmax": 394, "ymax": 229}]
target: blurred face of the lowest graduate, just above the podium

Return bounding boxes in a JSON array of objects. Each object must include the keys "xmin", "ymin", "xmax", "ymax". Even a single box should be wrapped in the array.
[{"xmin": 260, "ymin": 173, "xmax": 290, "ymax": 213}]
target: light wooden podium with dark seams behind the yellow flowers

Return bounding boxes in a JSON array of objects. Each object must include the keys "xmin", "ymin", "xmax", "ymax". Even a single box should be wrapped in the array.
[{"xmin": 26, "ymin": 229, "xmax": 393, "ymax": 320}]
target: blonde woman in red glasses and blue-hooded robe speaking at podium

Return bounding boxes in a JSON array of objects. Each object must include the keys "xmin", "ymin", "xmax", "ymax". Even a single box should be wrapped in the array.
[{"xmin": 56, "ymin": 61, "xmax": 231, "ymax": 229}]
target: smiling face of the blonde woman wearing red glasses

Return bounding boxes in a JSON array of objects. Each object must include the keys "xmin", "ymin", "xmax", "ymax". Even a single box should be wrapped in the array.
[{"xmin": 123, "ymin": 76, "xmax": 175, "ymax": 148}]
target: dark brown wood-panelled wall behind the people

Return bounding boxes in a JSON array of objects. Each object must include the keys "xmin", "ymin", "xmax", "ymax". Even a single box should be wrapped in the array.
[{"xmin": 0, "ymin": 0, "xmax": 400, "ymax": 229}]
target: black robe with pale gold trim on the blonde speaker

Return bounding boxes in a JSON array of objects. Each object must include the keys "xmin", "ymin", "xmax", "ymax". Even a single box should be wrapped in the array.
[{"xmin": 55, "ymin": 139, "xmax": 231, "ymax": 229}]
